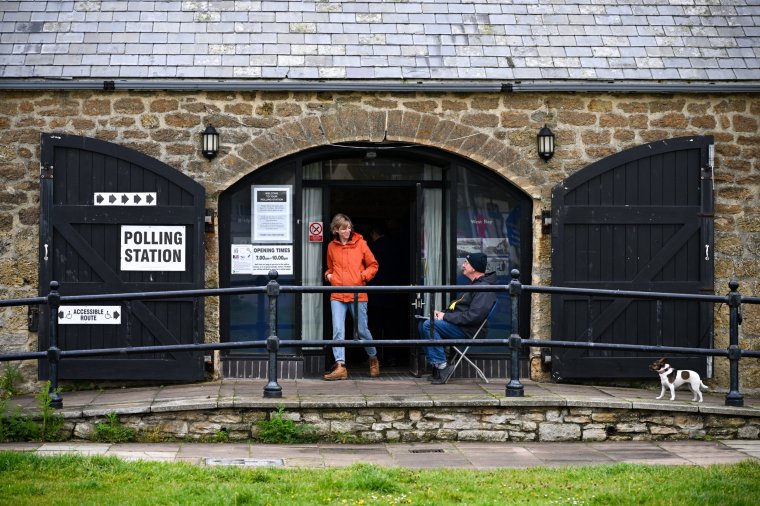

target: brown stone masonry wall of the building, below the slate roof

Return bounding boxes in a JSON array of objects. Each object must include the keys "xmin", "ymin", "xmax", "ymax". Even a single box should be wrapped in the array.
[{"xmin": 0, "ymin": 91, "xmax": 760, "ymax": 388}]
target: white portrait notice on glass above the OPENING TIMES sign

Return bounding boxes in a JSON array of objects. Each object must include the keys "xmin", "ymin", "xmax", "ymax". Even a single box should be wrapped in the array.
[{"xmin": 251, "ymin": 185, "xmax": 293, "ymax": 244}]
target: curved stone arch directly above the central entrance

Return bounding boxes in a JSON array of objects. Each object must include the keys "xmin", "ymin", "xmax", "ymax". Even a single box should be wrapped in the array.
[{"xmin": 225, "ymin": 107, "xmax": 546, "ymax": 200}]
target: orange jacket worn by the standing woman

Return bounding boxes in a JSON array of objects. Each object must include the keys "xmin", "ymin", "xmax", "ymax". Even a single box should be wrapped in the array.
[{"xmin": 325, "ymin": 232, "xmax": 378, "ymax": 302}]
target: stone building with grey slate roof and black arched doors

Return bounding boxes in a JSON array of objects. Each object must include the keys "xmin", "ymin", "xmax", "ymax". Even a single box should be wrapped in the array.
[{"xmin": 0, "ymin": 0, "xmax": 760, "ymax": 388}]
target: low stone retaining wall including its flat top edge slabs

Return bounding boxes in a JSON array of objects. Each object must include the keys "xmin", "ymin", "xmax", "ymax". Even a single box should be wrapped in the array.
[{"xmin": 26, "ymin": 398, "xmax": 760, "ymax": 442}]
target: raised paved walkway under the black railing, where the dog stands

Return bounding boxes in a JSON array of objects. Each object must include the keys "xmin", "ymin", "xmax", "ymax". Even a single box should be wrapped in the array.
[{"xmin": 9, "ymin": 377, "xmax": 760, "ymax": 417}]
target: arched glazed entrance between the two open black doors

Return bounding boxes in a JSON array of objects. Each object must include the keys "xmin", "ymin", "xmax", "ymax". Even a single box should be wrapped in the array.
[{"xmin": 219, "ymin": 142, "xmax": 533, "ymax": 378}]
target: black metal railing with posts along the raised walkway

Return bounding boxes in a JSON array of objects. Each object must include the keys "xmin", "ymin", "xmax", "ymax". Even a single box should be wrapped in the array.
[{"xmin": 0, "ymin": 270, "xmax": 760, "ymax": 408}]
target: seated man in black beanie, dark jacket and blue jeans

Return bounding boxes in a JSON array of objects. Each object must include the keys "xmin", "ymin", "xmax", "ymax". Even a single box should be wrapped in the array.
[{"xmin": 419, "ymin": 253, "xmax": 496, "ymax": 385}]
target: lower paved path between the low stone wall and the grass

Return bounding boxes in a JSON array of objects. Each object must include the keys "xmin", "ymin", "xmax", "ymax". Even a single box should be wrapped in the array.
[{"xmin": 0, "ymin": 440, "xmax": 760, "ymax": 469}]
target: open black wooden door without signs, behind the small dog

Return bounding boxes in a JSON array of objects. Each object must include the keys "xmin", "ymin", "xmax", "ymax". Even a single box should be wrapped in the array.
[{"xmin": 552, "ymin": 137, "xmax": 713, "ymax": 380}]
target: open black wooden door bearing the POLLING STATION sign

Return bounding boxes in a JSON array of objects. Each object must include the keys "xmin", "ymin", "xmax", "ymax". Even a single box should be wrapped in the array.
[{"xmin": 39, "ymin": 134, "xmax": 205, "ymax": 380}]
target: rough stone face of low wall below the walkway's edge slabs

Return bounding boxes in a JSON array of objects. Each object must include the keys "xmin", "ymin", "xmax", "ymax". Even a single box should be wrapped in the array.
[{"xmin": 59, "ymin": 406, "xmax": 760, "ymax": 443}]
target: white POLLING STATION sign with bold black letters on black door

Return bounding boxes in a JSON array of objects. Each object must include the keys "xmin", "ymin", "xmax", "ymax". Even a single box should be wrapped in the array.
[{"xmin": 121, "ymin": 225, "xmax": 186, "ymax": 271}]
